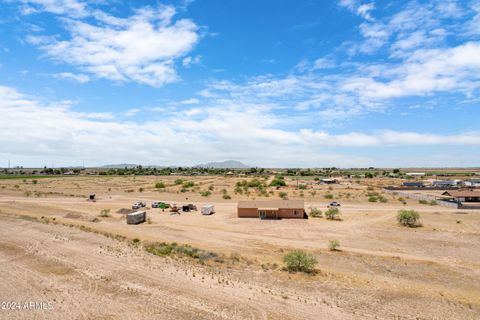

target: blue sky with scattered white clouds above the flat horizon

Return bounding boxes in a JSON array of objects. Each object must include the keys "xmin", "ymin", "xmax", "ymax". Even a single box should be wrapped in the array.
[{"xmin": 0, "ymin": 0, "xmax": 480, "ymax": 167}]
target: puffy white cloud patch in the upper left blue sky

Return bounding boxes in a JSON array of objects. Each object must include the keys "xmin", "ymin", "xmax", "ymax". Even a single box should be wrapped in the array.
[{"xmin": 28, "ymin": 6, "xmax": 199, "ymax": 87}]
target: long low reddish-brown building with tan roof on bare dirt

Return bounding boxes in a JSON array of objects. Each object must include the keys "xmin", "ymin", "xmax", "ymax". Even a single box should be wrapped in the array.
[{"xmin": 237, "ymin": 200, "xmax": 306, "ymax": 219}]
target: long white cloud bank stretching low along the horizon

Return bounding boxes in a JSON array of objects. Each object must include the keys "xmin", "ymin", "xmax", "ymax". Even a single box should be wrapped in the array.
[{"xmin": 0, "ymin": 87, "xmax": 480, "ymax": 166}]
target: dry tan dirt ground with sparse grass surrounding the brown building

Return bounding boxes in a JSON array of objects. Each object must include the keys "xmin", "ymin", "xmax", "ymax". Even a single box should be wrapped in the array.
[{"xmin": 0, "ymin": 177, "xmax": 480, "ymax": 319}]
